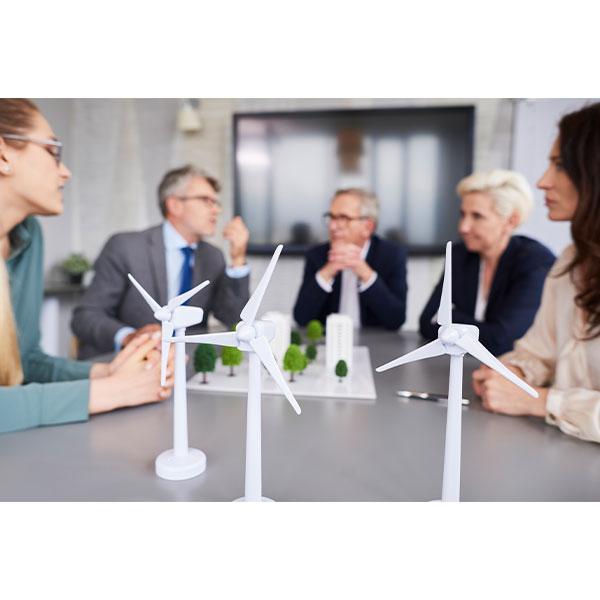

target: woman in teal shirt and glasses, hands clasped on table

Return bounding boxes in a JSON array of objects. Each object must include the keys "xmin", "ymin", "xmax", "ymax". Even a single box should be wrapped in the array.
[{"xmin": 0, "ymin": 99, "xmax": 173, "ymax": 432}]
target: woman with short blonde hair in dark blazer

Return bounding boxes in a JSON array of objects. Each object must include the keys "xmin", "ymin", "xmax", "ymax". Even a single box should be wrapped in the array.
[{"xmin": 419, "ymin": 169, "xmax": 555, "ymax": 355}]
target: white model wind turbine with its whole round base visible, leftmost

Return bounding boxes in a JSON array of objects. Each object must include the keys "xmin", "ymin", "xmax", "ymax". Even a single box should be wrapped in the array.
[{"xmin": 128, "ymin": 273, "xmax": 210, "ymax": 480}]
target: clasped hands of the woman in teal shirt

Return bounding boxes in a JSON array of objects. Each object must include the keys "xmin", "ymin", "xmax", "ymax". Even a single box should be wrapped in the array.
[{"xmin": 89, "ymin": 336, "xmax": 175, "ymax": 414}]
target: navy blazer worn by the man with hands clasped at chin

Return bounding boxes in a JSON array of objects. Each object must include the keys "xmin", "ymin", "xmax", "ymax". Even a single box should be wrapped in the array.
[{"xmin": 294, "ymin": 235, "xmax": 408, "ymax": 329}]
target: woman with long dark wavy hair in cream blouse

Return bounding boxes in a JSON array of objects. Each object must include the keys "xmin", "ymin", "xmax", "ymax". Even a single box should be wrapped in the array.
[{"xmin": 473, "ymin": 103, "xmax": 600, "ymax": 442}]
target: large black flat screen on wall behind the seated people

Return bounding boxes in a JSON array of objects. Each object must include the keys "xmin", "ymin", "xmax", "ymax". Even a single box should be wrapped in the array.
[{"xmin": 233, "ymin": 106, "xmax": 475, "ymax": 254}]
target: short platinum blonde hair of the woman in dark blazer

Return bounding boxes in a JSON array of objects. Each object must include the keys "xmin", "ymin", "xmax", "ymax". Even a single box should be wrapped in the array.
[{"xmin": 456, "ymin": 169, "xmax": 533, "ymax": 225}]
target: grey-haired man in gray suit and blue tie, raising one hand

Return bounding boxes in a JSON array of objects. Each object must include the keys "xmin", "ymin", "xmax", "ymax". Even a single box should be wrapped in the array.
[{"xmin": 71, "ymin": 165, "xmax": 250, "ymax": 359}]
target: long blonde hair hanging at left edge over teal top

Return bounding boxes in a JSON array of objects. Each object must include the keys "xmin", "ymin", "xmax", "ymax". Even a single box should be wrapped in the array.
[{"xmin": 0, "ymin": 258, "xmax": 23, "ymax": 385}]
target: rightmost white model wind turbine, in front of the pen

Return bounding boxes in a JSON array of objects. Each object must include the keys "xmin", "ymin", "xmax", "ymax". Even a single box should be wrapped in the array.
[{"xmin": 376, "ymin": 242, "xmax": 538, "ymax": 502}]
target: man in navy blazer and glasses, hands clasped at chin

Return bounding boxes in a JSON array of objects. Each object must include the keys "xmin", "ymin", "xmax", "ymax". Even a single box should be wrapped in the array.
[{"xmin": 294, "ymin": 188, "xmax": 407, "ymax": 329}]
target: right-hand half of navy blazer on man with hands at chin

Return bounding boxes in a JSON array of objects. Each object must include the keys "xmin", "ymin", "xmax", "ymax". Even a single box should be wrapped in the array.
[{"xmin": 359, "ymin": 238, "xmax": 408, "ymax": 329}]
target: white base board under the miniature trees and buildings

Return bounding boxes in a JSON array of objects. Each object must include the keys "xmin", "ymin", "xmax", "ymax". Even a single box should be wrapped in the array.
[{"xmin": 187, "ymin": 346, "xmax": 376, "ymax": 400}]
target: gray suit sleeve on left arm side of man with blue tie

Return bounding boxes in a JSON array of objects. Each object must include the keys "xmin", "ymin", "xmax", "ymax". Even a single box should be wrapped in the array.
[{"xmin": 71, "ymin": 234, "xmax": 137, "ymax": 353}]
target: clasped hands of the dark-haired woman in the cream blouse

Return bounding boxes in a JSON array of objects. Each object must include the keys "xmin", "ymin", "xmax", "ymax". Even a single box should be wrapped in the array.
[{"xmin": 473, "ymin": 365, "xmax": 548, "ymax": 417}]
